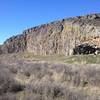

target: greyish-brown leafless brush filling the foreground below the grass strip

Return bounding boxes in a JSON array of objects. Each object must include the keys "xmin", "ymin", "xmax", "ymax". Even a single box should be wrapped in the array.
[{"xmin": 0, "ymin": 55, "xmax": 100, "ymax": 100}]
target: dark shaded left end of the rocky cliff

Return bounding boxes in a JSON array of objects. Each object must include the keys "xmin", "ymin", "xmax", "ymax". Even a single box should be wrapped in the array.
[{"xmin": 1, "ymin": 34, "xmax": 27, "ymax": 53}]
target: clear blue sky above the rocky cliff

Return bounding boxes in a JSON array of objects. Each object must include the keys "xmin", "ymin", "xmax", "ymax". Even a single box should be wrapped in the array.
[{"xmin": 0, "ymin": 0, "xmax": 100, "ymax": 43}]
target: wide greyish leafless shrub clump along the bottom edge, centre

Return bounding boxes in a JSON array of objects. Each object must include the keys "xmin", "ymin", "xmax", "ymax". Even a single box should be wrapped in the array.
[{"xmin": 27, "ymin": 83, "xmax": 94, "ymax": 100}]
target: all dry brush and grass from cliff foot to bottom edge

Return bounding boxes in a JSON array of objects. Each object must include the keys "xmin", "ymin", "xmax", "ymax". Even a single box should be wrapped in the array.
[{"xmin": 0, "ymin": 54, "xmax": 100, "ymax": 100}]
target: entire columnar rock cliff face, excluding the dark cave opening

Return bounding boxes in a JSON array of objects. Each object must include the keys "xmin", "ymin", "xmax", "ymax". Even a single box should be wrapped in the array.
[{"xmin": 0, "ymin": 14, "xmax": 100, "ymax": 55}]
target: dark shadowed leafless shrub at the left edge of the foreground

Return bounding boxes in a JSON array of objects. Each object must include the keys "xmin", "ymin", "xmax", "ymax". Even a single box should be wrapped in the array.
[{"xmin": 0, "ymin": 69, "xmax": 23, "ymax": 95}]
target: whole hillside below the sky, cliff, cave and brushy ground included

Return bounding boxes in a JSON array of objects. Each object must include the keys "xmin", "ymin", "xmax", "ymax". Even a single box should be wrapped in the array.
[{"xmin": 0, "ymin": 14, "xmax": 100, "ymax": 100}]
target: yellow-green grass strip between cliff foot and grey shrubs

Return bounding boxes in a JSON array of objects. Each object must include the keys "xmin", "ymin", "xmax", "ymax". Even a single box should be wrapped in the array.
[{"xmin": 13, "ymin": 53, "xmax": 100, "ymax": 64}]
